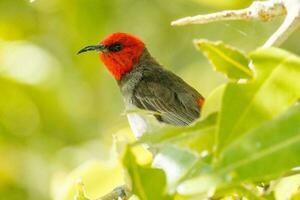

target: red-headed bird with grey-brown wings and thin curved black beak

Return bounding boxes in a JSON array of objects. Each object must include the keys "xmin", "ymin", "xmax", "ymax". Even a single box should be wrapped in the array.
[{"xmin": 78, "ymin": 32, "xmax": 205, "ymax": 138}]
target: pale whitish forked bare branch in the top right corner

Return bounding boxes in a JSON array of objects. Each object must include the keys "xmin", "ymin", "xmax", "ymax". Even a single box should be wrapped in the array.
[{"xmin": 171, "ymin": 0, "xmax": 300, "ymax": 47}]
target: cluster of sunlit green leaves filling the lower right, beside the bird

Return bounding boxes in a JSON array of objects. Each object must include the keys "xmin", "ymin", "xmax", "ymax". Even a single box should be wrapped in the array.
[{"xmin": 118, "ymin": 40, "xmax": 300, "ymax": 199}]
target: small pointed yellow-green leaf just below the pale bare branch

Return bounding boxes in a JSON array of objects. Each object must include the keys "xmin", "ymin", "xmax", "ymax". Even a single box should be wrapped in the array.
[{"xmin": 195, "ymin": 39, "xmax": 253, "ymax": 80}]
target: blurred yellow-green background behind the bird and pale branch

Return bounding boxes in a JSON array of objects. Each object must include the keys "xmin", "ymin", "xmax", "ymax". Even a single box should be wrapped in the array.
[{"xmin": 0, "ymin": 0, "xmax": 300, "ymax": 200}]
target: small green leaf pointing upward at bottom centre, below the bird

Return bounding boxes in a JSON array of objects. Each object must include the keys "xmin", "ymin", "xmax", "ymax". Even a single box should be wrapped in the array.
[{"xmin": 123, "ymin": 147, "xmax": 171, "ymax": 200}]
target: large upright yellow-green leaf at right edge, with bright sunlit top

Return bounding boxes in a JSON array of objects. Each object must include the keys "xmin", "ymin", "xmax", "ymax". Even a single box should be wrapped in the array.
[{"xmin": 217, "ymin": 48, "xmax": 300, "ymax": 151}]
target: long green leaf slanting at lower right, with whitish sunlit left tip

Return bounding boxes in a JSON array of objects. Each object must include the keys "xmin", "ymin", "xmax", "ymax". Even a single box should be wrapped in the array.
[{"xmin": 178, "ymin": 104, "xmax": 300, "ymax": 195}]
